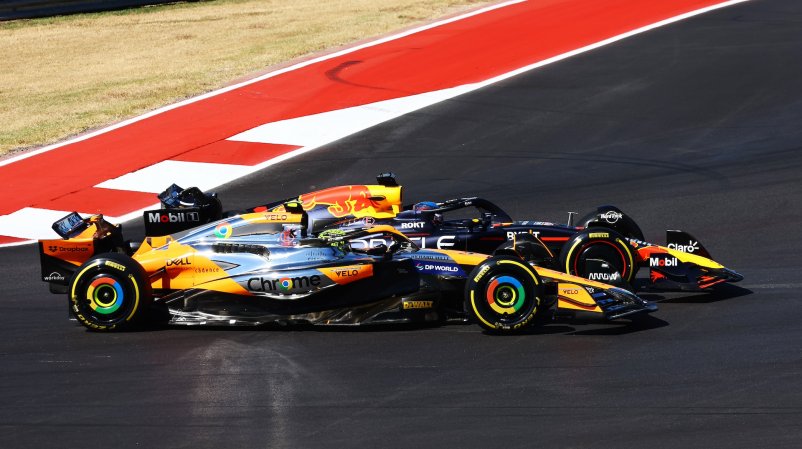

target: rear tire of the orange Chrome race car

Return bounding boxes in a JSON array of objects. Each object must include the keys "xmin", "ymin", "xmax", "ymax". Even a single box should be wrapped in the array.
[{"xmin": 67, "ymin": 253, "xmax": 153, "ymax": 331}]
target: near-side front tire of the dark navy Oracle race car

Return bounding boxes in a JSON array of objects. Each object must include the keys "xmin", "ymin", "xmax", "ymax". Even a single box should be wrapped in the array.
[{"xmin": 560, "ymin": 227, "xmax": 638, "ymax": 284}]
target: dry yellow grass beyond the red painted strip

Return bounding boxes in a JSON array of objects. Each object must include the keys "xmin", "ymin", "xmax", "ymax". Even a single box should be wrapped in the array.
[{"xmin": 0, "ymin": 0, "xmax": 488, "ymax": 155}]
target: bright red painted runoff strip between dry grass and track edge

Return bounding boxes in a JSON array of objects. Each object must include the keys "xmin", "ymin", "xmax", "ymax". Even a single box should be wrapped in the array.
[{"xmin": 0, "ymin": 0, "xmax": 722, "ymax": 215}]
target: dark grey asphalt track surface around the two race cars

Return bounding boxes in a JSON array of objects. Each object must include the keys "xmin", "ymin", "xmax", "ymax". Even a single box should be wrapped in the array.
[{"xmin": 0, "ymin": 0, "xmax": 802, "ymax": 448}]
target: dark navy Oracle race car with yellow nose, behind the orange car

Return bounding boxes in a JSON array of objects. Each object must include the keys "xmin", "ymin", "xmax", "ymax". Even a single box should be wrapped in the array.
[{"xmin": 177, "ymin": 173, "xmax": 743, "ymax": 291}]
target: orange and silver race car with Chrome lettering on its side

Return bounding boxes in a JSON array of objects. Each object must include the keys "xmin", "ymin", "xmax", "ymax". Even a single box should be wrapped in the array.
[{"xmin": 39, "ymin": 206, "xmax": 656, "ymax": 333}]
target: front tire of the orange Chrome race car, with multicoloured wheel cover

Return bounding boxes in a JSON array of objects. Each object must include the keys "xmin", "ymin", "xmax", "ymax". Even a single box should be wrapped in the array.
[{"xmin": 465, "ymin": 256, "xmax": 545, "ymax": 334}]
